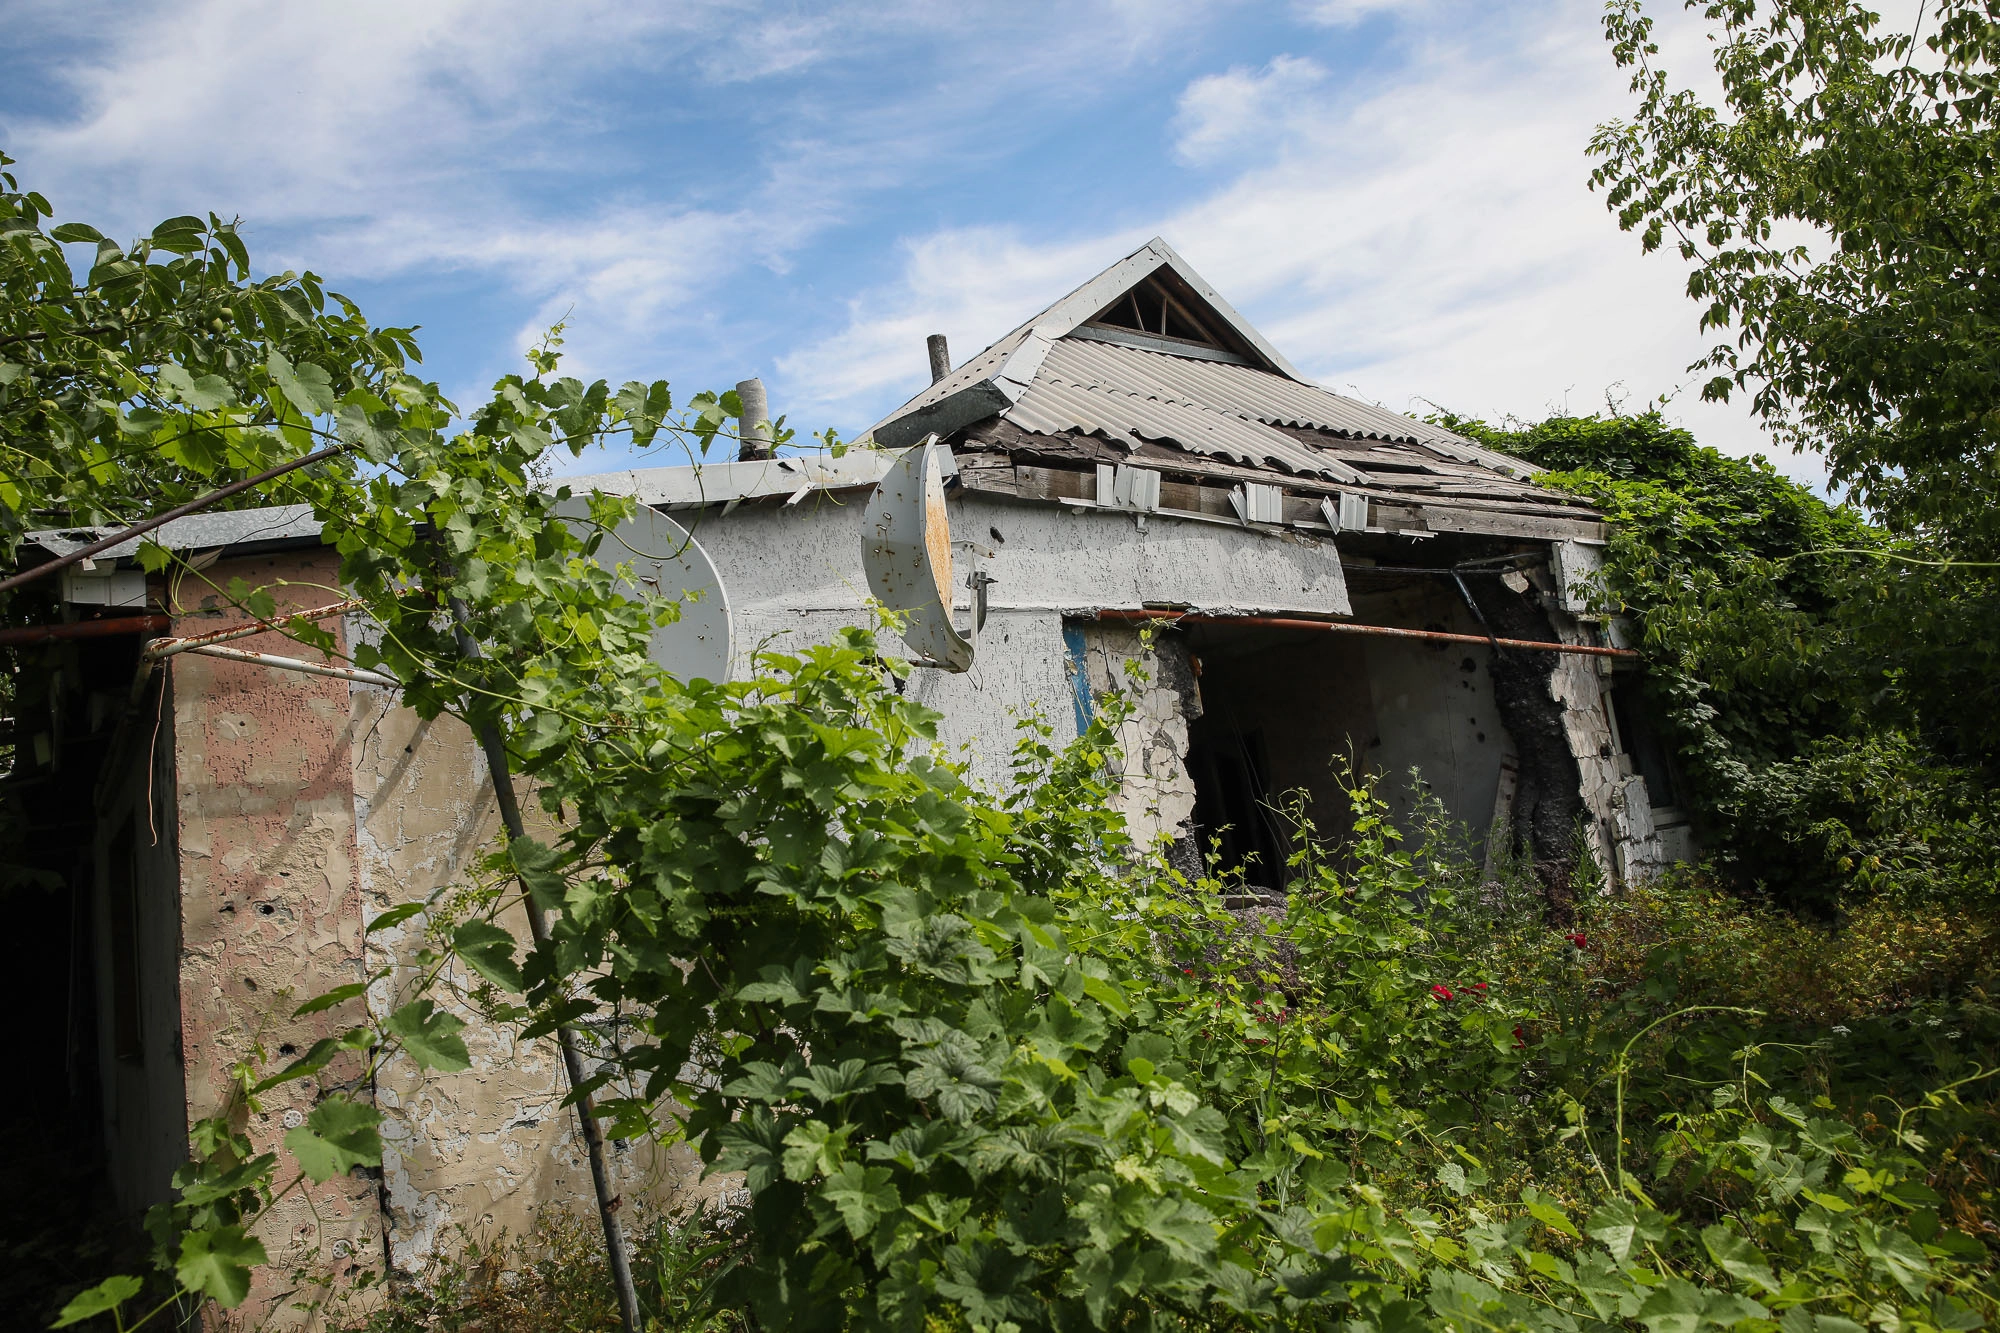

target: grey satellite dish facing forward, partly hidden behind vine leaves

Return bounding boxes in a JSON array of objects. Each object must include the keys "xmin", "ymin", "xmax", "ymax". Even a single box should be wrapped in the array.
[{"xmin": 554, "ymin": 496, "xmax": 736, "ymax": 681}]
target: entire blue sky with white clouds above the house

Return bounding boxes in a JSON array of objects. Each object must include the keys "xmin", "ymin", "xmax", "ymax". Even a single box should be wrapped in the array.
[{"xmin": 0, "ymin": 0, "xmax": 1822, "ymax": 480}]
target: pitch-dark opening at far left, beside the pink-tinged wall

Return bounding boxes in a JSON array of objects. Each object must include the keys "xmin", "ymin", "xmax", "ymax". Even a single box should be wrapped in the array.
[{"xmin": 0, "ymin": 608, "xmax": 178, "ymax": 1327}]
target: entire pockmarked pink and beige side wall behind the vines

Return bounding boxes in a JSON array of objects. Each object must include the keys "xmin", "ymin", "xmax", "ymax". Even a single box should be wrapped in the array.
[{"xmin": 162, "ymin": 552, "xmax": 720, "ymax": 1329}]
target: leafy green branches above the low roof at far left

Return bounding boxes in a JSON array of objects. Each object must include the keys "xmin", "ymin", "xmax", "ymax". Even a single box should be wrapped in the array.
[{"xmin": 0, "ymin": 154, "xmax": 418, "ymax": 562}]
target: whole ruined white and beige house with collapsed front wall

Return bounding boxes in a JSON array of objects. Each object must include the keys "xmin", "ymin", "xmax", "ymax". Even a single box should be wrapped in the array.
[{"xmin": 6, "ymin": 240, "xmax": 1690, "ymax": 1303}]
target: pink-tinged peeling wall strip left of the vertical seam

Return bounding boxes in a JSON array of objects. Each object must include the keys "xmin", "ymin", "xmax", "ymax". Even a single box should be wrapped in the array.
[{"xmin": 166, "ymin": 550, "xmax": 382, "ymax": 1329}]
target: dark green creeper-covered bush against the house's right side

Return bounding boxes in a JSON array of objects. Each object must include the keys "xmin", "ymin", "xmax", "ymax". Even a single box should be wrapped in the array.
[{"xmin": 1442, "ymin": 412, "xmax": 2000, "ymax": 917}]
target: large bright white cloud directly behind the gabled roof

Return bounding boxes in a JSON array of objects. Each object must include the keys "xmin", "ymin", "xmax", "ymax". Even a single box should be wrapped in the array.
[{"xmin": 786, "ymin": 0, "xmax": 1824, "ymax": 484}]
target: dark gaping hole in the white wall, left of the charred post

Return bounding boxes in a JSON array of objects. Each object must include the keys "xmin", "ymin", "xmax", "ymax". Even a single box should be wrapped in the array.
[{"xmin": 1066, "ymin": 584, "xmax": 1514, "ymax": 889}]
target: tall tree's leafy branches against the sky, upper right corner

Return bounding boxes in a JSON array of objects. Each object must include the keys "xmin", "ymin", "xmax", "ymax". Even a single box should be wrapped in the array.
[{"xmin": 1590, "ymin": 0, "xmax": 2000, "ymax": 558}]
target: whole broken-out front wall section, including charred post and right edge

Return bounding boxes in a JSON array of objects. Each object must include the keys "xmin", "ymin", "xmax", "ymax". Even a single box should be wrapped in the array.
[{"xmin": 1066, "ymin": 548, "xmax": 1670, "ymax": 892}]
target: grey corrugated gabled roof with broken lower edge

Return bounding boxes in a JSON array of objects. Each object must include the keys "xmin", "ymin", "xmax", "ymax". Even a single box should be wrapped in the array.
[{"xmin": 868, "ymin": 238, "xmax": 1596, "ymax": 530}]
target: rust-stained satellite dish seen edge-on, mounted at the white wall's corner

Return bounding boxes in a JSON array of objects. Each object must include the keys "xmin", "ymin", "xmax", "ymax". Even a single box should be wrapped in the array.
[{"xmin": 862, "ymin": 434, "xmax": 972, "ymax": 671}]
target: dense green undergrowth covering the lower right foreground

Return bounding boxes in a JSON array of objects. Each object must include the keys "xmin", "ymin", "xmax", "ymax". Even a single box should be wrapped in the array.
[{"xmin": 296, "ymin": 784, "xmax": 2000, "ymax": 1333}]
